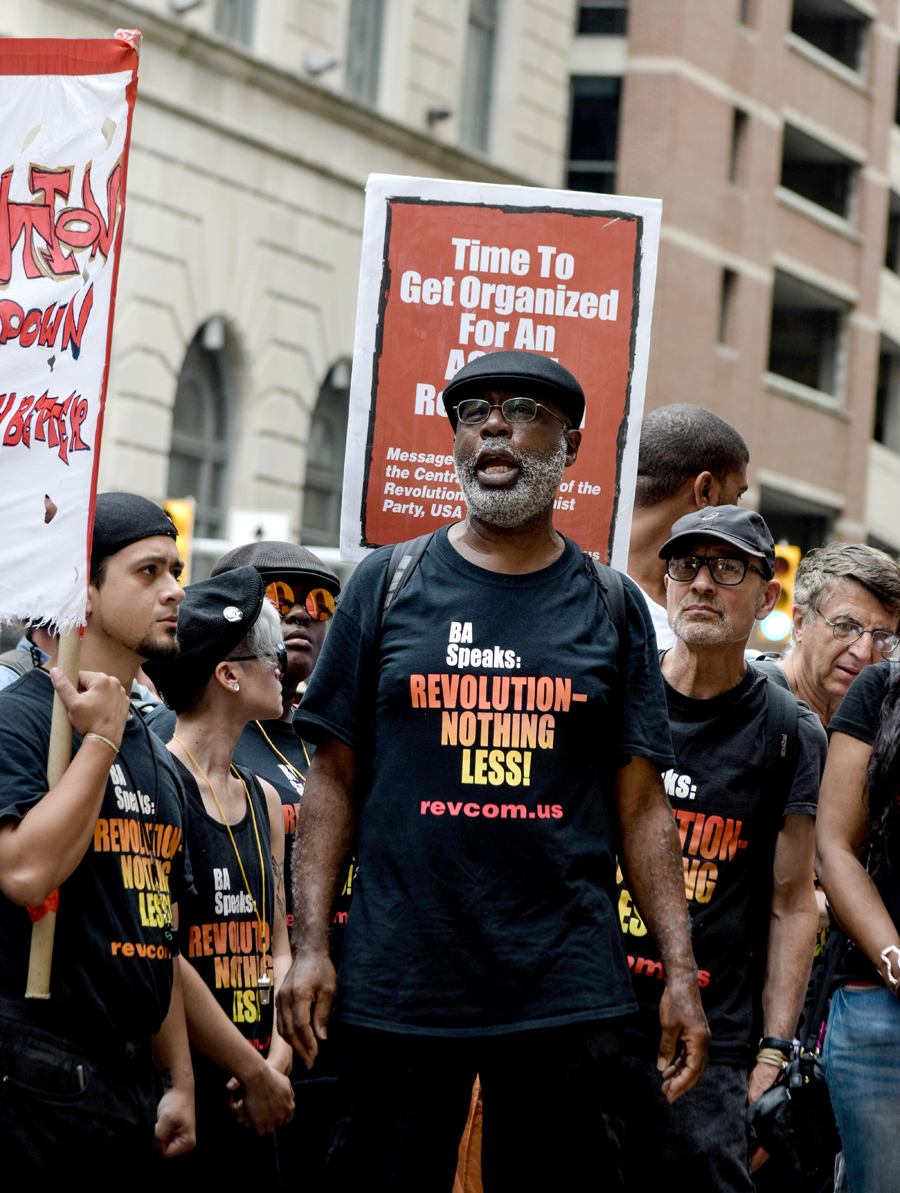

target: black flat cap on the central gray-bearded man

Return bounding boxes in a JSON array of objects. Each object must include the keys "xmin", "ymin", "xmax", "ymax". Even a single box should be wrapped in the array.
[{"xmin": 443, "ymin": 348, "xmax": 585, "ymax": 431}]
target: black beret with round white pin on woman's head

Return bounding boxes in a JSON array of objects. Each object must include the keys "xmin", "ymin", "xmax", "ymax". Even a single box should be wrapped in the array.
[{"xmin": 143, "ymin": 568, "xmax": 265, "ymax": 706}]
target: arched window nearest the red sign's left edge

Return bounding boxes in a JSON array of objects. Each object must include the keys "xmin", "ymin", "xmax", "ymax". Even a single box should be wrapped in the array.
[{"xmin": 302, "ymin": 360, "xmax": 350, "ymax": 546}]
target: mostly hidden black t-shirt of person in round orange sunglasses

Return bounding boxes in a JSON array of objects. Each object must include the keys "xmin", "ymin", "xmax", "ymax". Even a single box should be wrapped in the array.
[{"xmin": 147, "ymin": 704, "xmax": 353, "ymax": 959}]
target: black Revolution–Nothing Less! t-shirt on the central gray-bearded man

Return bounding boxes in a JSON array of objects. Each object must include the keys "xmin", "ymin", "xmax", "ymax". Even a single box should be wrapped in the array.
[{"xmin": 295, "ymin": 530, "xmax": 672, "ymax": 1036}]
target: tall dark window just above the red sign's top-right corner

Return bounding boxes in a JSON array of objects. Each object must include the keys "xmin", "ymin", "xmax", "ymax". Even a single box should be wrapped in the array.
[{"xmin": 567, "ymin": 76, "xmax": 622, "ymax": 194}]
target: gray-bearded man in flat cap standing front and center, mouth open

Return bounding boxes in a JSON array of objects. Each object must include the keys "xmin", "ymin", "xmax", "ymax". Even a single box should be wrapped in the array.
[{"xmin": 278, "ymin": 352, "xmax": 708, "ymax": 1193}]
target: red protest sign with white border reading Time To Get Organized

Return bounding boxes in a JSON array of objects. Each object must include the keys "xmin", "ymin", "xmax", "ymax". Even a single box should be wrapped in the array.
[{"xmin": 341, "ymin": 174, "xmax": 661, "ymax": 569}]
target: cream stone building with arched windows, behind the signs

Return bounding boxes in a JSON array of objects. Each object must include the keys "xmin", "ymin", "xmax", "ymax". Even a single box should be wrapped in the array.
[{"xmin": 0, "ymin": 0, "xmax": 573, "ymax": 576}]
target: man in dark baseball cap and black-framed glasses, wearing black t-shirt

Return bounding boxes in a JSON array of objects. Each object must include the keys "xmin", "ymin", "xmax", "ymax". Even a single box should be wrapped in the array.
[{"xmin": 618, "ymin": 506, "xmax": 827, "ymax": 1193}]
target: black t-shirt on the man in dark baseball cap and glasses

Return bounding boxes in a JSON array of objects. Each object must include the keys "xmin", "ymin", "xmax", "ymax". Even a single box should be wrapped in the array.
[{"xmin": 618, "ymin": 667, "xmax": 827, "ymax": 1063}]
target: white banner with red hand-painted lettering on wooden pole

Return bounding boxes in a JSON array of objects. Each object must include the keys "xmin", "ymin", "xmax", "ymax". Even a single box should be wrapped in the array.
[{"xmin": 0, "ymin": 32, "xmax": 140, "ymax": 629}]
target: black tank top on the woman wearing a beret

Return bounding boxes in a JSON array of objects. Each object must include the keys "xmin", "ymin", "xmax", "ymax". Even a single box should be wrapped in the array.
[{"xmin": 175, "ymin": 758, "xmax": 275, "ymax": 1056}]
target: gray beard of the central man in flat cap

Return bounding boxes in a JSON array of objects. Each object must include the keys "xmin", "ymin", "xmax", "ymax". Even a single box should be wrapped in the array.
[{"xmin": 454, "ymin": 437, "xmax": 567, "ymax": 530}]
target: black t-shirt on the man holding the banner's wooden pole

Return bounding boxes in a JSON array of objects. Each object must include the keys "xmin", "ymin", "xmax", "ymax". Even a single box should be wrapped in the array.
[{"xmin": 0, "ymin": 670, "xmax": 190, "ymax": 1039}]
